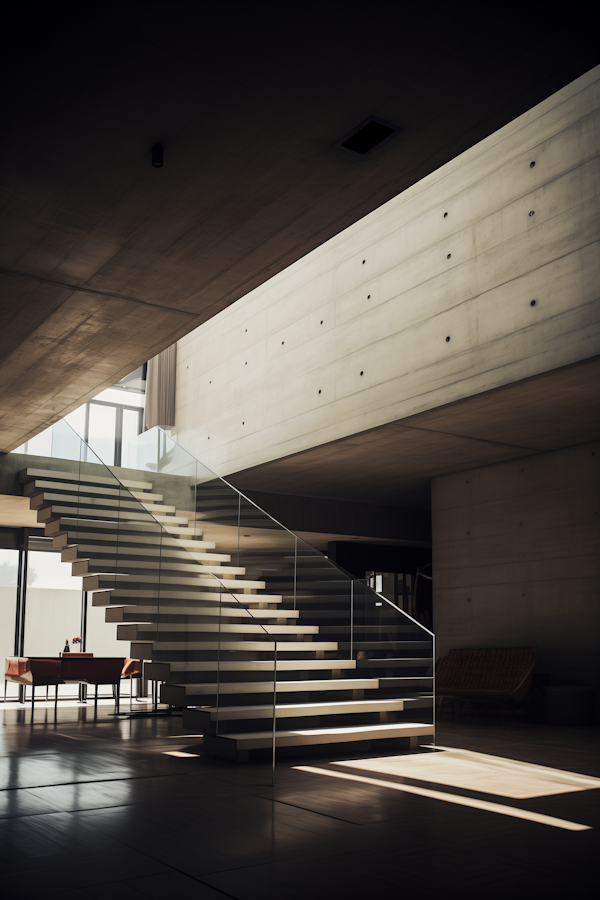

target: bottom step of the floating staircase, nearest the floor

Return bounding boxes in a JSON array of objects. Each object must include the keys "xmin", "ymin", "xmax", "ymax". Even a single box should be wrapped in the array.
[{"xmin": 203, "ymin": 722, "xmax": 433, "ymax": 761}]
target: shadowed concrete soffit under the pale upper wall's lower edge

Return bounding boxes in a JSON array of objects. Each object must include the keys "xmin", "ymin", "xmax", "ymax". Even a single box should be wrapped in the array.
[{"xmin": 227, "ymin": 356, "xmax": 600, "ymax": 509}]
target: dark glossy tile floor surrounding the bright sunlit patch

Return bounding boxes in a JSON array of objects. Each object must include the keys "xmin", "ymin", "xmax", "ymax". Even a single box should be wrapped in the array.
[{"xmin": 0, "ymin": 704, "xmax": 600, "ymax": 900}]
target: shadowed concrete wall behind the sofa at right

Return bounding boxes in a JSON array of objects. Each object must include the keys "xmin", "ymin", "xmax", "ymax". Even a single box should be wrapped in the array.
[{"xmin": 432, "ymin": 444, "xmax": 600, "ymax": 688}]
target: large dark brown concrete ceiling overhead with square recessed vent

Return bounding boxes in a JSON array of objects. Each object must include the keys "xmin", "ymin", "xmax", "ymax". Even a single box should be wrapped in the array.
[{"xmin": 0, "ymin": 2, "xmax": 600, "ymax": 450}]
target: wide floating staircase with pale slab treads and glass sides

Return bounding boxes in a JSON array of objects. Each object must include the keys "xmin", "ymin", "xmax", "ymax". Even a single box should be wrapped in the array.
[{"xmin": 20, "ymin": 460, "xmax": 433, "ymax": 761}]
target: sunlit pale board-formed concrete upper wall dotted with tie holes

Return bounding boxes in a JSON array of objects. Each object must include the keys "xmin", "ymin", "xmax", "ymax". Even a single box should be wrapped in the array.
[{"xmin": 172, "ymin": 67, "xmax": 600, "ymax": 475}]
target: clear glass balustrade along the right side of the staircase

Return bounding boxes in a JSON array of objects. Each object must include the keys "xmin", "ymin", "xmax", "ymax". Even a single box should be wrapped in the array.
[{"xmin": 120, "ymin": 429, "xmax": 434, "ymax": 760}]
